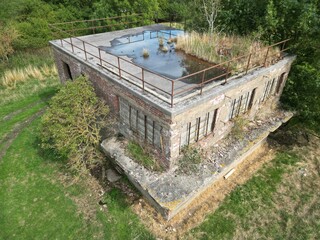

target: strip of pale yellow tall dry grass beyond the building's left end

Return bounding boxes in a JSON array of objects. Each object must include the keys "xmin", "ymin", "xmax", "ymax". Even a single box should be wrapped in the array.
[{"xmin": 0, "ymin": 65, "xmax": 57, "ymax": 88}]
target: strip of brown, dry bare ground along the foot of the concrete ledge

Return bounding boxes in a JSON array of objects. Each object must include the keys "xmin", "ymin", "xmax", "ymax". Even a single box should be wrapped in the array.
[{"xmin": 132, "ymin": 144, "xmax": 275, "ymax": 239}]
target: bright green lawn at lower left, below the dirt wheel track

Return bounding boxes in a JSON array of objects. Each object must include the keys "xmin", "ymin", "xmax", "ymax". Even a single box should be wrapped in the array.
[{"xmin": 0, "ymin": 119, "xmax": 152, "ymax": 239}]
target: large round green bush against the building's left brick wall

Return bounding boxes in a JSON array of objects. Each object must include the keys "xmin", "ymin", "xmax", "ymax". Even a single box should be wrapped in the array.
[{"xmin": 40, "ymin": 76, "xmax": 109, "ymax": 175}]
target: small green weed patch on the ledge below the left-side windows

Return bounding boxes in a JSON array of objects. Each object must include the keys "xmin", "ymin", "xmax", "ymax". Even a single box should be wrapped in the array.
[{"xmin": 127, "ymin": 141, "xmax": 163, "ymax": 171}]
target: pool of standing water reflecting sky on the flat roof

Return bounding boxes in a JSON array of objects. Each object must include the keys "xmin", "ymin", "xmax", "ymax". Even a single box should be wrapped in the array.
[{"xmin": 105, "ymin": 30, "xmax": 223, "ymax": 83}]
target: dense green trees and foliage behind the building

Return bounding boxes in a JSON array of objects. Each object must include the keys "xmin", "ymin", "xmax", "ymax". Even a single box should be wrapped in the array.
[{"xmin": 0, "ymin": 0, "xmax": 320, "ymax": 130}]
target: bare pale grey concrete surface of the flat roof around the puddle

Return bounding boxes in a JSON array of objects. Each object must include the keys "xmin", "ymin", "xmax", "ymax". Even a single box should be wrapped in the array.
[{"xmin": 50, "ymin": 24, "xmax": 292, "ymax": 114}]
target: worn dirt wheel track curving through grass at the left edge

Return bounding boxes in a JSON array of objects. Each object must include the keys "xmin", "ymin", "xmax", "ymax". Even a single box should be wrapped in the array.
[{"xmin": 0, "ymin": 108, "xmax": 46, "ymax": 162}]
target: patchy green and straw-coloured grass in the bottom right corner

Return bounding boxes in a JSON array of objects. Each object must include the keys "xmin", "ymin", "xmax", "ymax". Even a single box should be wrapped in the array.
[{"xmin": 188, "ymin": 149, "xmax": 320, "ymax": 239}]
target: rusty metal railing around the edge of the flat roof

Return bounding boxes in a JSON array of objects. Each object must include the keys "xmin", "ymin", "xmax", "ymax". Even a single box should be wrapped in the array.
[{"xmin": 50, "ymin": 17, "xmax": 290, "ymax": 107}]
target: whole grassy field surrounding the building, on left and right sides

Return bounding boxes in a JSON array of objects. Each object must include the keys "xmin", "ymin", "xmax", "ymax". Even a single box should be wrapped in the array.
[{"xmin": 0, "ymin": 49, "xmax": 320, "ymax": 239}]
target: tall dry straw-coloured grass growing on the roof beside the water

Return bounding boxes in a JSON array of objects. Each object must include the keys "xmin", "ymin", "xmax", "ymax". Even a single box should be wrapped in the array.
[{"xmin": 176, "ymin": 32, "xmax": 280, "ymax": 72}]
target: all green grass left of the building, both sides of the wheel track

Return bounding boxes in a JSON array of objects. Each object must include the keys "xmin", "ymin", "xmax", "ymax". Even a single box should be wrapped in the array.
[{"xmin": 0, "ymin": 50, "xmax": 154, "ymax": 239}]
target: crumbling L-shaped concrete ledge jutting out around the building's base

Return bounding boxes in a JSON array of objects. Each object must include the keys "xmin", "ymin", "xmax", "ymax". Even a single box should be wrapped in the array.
[{"xmin": 101, "ymin": 109, "xmax": 293, "ymax": 220}]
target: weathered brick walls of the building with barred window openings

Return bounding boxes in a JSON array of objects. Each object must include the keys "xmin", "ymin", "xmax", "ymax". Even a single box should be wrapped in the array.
[{"xmin": 54, "ymin": 47, "xmax": 294, "ymax": 167}]
